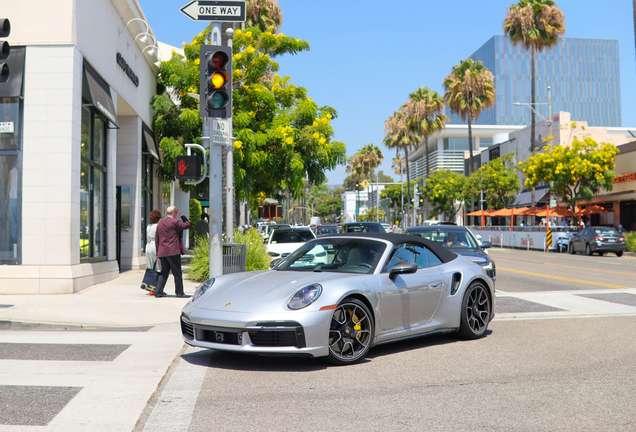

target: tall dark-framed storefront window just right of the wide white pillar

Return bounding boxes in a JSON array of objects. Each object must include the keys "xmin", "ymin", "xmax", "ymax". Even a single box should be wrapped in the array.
[{"xmin": 80, "ymin": 108, "xmax": 106, "ymax": 259}]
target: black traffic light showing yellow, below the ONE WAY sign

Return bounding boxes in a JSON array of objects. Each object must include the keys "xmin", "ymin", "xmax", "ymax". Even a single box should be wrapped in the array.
[{"xmin": 199, "ymin": 45, "xmax": 232, "ymax": 119}]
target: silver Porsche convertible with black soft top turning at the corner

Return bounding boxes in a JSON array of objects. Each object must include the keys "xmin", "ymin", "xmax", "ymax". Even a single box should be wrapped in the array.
[{"xmin": 181, "ymin": 233, "xmax": 495, "ymax": 365}]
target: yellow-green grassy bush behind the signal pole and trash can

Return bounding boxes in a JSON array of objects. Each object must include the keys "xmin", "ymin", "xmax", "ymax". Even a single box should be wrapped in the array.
[{"xmin": 188, "ymin": 228, "xmax": 270, "ymax": 282}]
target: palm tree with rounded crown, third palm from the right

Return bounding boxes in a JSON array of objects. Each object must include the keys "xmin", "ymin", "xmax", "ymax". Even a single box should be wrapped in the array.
[{"xmin": 405, "ymin": 87, "xmax": 448, "ymax": 177}]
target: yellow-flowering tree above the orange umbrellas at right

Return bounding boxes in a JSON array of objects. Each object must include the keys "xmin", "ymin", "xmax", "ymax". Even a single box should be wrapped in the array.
[{"xmin": 519, "ymin": 137, "xmax": 618, "ymax": 210}]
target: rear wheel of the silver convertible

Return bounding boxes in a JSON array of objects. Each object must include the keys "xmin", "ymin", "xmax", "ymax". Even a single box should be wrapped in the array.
[{"xmin": 458, "ymin": 282, "xmax": 492, "ymax": 339}]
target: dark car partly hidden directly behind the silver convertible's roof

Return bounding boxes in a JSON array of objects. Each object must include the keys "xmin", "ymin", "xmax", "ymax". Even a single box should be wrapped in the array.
[{"xmin": 406, "ymin": 225, "xmax": 497, "ymax": 281}]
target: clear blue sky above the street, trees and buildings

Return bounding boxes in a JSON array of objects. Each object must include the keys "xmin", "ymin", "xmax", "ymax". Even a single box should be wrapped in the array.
[{"xmin": 139, "ymin": 0, "xmax": 636, "ymax": 184}]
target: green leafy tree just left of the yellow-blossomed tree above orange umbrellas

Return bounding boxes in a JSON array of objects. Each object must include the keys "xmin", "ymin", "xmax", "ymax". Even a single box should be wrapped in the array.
[{"xmin": 465, "ymin": 153, "xmax": 521, "ymax": 209}]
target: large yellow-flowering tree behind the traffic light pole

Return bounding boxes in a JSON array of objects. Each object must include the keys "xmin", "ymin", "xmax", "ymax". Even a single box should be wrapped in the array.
[{"xmin": 153, "ymin": 22, "xmax": 346, "ymax": 204}]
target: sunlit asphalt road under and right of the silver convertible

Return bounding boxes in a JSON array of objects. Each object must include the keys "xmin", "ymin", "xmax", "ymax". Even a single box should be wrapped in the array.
[{"xmin": 136, "ymin": 250, "xmax": 636, "ymax": 432}]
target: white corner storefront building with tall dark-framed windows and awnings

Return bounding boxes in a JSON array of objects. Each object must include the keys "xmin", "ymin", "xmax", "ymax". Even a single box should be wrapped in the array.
[{"xmin": 0, "ymin": 0, "xmax": 162, "ymax": 294}]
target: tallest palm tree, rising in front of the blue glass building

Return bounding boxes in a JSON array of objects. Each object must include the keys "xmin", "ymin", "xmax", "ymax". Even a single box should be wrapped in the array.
[{"xmin": 503, "ymin": 0, "xmax": 565, "ymax": 155}]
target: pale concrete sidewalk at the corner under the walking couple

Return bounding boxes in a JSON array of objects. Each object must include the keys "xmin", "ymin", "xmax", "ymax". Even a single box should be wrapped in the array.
[{"xmin": 0, "ymin": 268, "xmax": 199, "ymax": 327}]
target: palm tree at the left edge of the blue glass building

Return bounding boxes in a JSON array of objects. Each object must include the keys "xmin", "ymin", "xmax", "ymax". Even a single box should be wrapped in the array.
[{"xmin": 443, "ymin": 58, "xmax": 495, "ymax": 175}]
